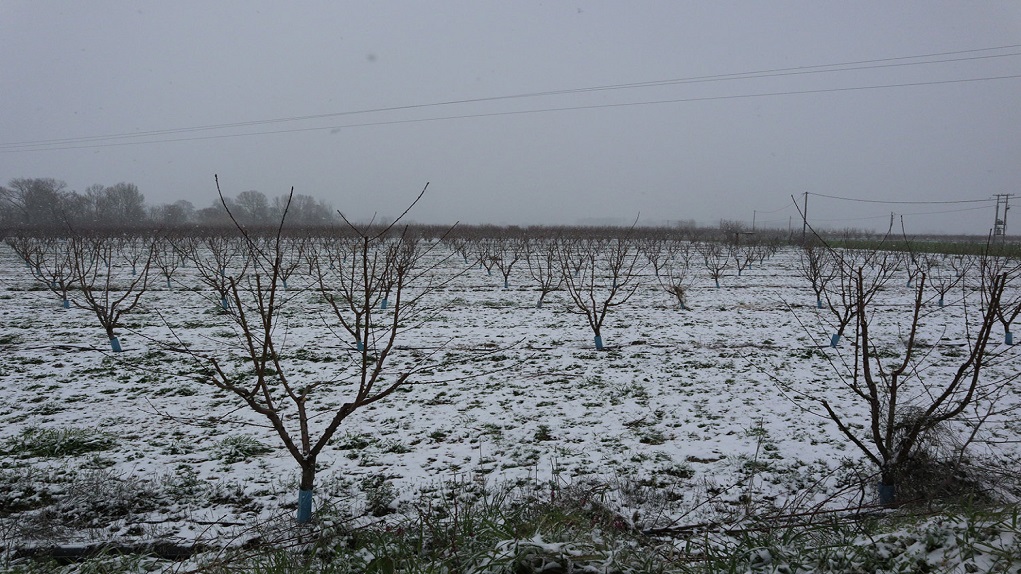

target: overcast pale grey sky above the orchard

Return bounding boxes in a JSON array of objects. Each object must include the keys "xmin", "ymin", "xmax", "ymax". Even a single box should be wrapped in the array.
[{"xmin": 0, "ymin": 0, "xmax": 1021, "ymax": 233}]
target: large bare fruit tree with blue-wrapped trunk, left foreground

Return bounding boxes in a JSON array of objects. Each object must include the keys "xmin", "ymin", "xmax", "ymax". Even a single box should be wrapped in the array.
[{"xmin": 174, "ymin": 182, "xmax": 461, "ymax": 523}]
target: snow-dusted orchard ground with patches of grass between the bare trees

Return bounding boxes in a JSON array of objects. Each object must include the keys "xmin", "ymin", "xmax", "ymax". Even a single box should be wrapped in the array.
[{"xmin": 0, "ymin": 240, "xmax": 1021, "ymax": 543}]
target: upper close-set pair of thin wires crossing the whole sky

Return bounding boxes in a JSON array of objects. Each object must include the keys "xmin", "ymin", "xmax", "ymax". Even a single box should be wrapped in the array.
[{"xmin": 0, "ymin": 44, "xmax": 1021, "ymax": 151}]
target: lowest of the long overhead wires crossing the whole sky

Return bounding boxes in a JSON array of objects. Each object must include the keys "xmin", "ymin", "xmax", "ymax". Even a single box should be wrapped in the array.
[{"xmin": 0, "ymin": 74, "xmax": 1021, "ymax": 154}]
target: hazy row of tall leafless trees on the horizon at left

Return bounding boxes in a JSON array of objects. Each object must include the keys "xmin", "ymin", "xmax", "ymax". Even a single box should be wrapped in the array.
[{"xmin": 0, "ymin": 178, "xmax": 337, "ymax": 231}]
